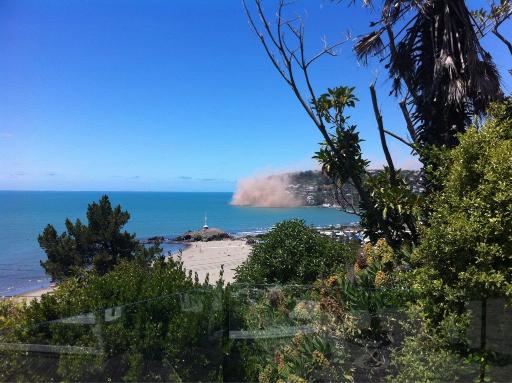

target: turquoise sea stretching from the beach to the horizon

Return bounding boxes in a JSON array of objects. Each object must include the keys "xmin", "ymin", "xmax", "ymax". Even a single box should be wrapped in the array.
[{"xmin": 0, "ymin": 191, "xmax": 356, "ymax": 295}]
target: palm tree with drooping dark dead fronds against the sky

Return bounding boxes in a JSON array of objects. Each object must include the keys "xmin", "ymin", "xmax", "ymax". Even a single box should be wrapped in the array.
[{"xmin": 355, "ymin": 0, "xmax": 502, "ymax": 148}]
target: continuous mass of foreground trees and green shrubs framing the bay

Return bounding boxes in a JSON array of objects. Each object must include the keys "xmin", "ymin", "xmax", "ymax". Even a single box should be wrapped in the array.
[{"xmin": 0, "ymin": 0, "xmax": 512, "ymax": 383}]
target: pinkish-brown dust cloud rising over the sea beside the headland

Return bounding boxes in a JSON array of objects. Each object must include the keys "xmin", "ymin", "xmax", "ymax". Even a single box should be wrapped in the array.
[{"xmin": 231, "ymin": 174, "xmax": 303, "ymax": 207}]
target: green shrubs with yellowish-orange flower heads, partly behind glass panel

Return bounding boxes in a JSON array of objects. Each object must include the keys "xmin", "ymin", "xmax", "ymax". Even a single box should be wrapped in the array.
[{"xmin": 229, "ymin": 241, "xmax": 408, "ymax": 382}]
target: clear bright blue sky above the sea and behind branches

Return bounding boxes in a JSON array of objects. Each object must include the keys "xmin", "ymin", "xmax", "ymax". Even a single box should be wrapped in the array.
[{"xmin": 0, "ymin": 0, "xmax": 512, "ymax": 191}]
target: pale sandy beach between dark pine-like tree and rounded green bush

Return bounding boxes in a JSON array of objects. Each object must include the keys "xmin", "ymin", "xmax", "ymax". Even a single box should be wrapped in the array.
[{"xmin": 175, "ymin": 239, "xmax": 251, "ymax": 283}]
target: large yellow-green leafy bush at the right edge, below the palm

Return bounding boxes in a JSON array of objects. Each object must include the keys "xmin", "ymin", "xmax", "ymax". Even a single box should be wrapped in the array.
[{"xmin": 413, "ymin": 101, "xmax": 512, "ymax": 316}]
